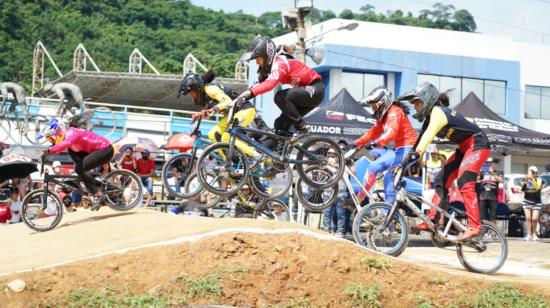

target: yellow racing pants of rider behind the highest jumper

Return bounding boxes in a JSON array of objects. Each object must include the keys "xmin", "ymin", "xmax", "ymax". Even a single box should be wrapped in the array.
[{"xmin": 208, "ymin": 108, "xmax": 256, "ymax": 157}]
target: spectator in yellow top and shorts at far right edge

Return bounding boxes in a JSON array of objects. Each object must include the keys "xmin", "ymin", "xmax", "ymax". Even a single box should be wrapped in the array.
[{"xmin": 521, "ymin": 166, "xmax": 546, "ymax": 241}]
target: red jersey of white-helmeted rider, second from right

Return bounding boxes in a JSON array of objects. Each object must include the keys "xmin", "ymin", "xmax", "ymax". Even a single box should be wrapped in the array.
[{"xmin": 355, "ymin": 104, "xmax": 417, "ymax": 148}]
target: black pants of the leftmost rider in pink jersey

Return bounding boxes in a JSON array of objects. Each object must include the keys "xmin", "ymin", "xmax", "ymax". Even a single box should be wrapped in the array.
[{"xmin": 69, "ymin": 145, "xmax": 115, "ymax": 194}]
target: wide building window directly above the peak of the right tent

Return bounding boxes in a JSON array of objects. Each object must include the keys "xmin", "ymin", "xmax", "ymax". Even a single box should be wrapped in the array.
[{"xmin": 417, "ymin": 74, "xmax": 508, "ymax": 114}]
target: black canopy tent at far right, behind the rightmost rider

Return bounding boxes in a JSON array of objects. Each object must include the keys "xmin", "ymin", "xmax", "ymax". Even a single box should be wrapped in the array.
[{"xmin": 455, "ymin": 92, "xmax": 550, "ymax": 149}]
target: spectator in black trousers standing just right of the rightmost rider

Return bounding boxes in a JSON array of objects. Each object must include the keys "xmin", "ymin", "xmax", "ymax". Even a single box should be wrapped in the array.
[{"xmin": 479, "ymin": 158, "xmax": 502, "ymax": 223}]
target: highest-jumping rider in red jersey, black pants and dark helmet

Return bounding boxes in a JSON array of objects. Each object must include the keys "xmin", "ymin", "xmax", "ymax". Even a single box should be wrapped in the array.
[{"xmin": 238, "ymin": 35, "xmax": 325, "ymax": 138}]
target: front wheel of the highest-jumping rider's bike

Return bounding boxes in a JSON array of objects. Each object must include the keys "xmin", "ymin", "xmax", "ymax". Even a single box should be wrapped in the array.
[{"xmin": 197, "ymin": 142, "xmax": 249, "ymax": 196}]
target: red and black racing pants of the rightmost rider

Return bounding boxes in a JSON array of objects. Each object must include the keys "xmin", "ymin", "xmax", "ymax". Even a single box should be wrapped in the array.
[{"xmin": 430, "ymin": 136, "xmax": 491, "ymax": 228}]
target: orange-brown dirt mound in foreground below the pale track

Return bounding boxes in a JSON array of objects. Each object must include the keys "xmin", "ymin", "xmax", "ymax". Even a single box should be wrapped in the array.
[{"xmin": 0, "ymin": 232, "xmax": 548, "ymax": 307}]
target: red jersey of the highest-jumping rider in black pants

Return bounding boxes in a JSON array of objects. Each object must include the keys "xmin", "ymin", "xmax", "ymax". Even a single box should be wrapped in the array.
[{"xmin": 250, "ymin": 56, "xmax": 321, "ymax": 96}]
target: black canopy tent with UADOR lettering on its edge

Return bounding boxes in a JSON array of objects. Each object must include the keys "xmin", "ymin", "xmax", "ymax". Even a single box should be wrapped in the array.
[{"xmin": 304, "ymin": 88, "xmax": 376, "ymax": 142}]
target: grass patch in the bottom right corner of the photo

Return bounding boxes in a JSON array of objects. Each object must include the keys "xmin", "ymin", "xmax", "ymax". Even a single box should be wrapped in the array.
[{"xmin": 461, "ymin": 283, "xmax": 550, "ymax": 308}]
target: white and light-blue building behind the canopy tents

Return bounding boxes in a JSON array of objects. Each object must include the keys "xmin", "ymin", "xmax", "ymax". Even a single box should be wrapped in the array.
[{"xmin": 249, "ymin": 19, "xmax": 550, "ymax": 173}]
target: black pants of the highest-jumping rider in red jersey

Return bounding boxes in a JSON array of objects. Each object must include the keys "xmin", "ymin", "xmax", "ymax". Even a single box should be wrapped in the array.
[{"xmin": 273, "ymin": 80, "xmax": 325, "ymax": 132}]
